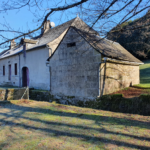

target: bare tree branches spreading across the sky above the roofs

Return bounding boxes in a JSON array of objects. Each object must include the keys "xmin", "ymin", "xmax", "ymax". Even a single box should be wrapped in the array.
[{"xmin": 0, "ymin": 0, "xmax": 150, "ymax": 47}]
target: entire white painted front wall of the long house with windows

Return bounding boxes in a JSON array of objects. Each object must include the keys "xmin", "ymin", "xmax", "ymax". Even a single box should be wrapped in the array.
[{"xmin": 0, "ymin": 48, "xmax": 50, "ymax": 90}]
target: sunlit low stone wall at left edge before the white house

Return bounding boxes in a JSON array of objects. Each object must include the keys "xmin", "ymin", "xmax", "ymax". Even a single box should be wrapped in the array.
[{"xmin": 0, "ymin": 88, "xmax": 29, "ymax": 101}]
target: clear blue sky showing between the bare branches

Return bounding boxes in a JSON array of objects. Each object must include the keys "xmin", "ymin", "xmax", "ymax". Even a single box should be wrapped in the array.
[{"xmin": 0, "ymin": 0, "xmax": 146, "ymax": 51}]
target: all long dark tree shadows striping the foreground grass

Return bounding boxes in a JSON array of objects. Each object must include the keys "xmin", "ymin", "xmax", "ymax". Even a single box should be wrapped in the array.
[{"xmin": 0, "ymin": 101, "xmax": 150, "ymax": 149}]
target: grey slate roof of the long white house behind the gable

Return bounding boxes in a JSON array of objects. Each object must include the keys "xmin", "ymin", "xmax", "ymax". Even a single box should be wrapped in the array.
[{"xmin": 0, "ymin": 17, "xmax": 98, "ymax": 59}]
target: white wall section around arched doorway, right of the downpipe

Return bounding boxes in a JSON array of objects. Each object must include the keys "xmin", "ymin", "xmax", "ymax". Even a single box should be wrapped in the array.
[{"xmin": 20, "ymin": 48, "xmax": 50, "ymax": 90}]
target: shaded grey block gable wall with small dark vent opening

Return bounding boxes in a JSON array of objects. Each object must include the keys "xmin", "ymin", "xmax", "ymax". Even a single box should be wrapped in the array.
[{"xmin": 50, "ymin": 28, "xmax": 101, "ymax": 98}]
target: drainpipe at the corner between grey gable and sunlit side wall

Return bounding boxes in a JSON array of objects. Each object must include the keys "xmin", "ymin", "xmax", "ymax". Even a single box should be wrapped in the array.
[{"xmin": 98, "ymin": 57, "xmax": 108, "ymax": 97}]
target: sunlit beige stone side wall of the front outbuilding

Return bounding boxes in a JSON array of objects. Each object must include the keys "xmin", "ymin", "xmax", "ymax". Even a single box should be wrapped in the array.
[{"xmin": 101, "ymin": 62, "xmax": 139, "ymax": 95}]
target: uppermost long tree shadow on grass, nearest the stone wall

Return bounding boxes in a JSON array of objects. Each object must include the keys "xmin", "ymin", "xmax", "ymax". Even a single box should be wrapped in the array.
[{"xmin": 3, "ymin": 104, "xmax": 150, "ymax": 129}]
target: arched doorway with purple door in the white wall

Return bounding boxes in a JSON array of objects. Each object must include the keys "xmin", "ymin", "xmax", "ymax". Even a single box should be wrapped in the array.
[{"xmin": 22, "ymin": 67, "xmax": 29, "ymax": 87}]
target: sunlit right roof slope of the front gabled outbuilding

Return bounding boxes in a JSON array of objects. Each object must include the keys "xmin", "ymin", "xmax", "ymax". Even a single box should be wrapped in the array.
[{"xmin": 74, "ymin": 28, "xmax": 143, "ymax": 63}]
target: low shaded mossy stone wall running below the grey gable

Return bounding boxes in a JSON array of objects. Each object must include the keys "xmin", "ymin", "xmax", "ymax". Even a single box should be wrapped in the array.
[{"xmin": 30, "ymin": 90, "xmax": 150, "ymax": 115}]
